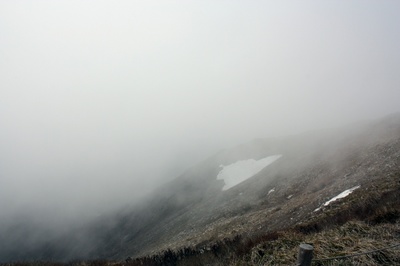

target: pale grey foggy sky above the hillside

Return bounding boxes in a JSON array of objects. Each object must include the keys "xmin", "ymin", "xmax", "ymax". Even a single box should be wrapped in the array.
[{"xmin": 0, "ymin": 0, "xmax": 400, "ymax": 222}]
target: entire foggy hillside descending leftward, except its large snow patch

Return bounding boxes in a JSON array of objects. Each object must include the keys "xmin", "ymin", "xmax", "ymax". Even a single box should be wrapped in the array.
[{"xmin": 0, "ymin": 114, "xmax": 400, "ymax": 265}]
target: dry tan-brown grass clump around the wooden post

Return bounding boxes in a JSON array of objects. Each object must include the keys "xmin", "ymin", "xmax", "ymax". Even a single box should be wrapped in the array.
[{"xmin": 232, "ymin": 221, "xmax": 400, "ymax": 266}]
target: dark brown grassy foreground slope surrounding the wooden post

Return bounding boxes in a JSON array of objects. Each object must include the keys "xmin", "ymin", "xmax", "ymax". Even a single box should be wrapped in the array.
[{"xmin": 6, "ymin": 154, "xmax": 400, "ymax": 266}]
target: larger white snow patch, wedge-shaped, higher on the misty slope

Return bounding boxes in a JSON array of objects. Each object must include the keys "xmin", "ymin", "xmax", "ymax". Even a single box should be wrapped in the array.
[{"xmin": 217, "ymin": 155, "xmax": 282, "ymax": 190}]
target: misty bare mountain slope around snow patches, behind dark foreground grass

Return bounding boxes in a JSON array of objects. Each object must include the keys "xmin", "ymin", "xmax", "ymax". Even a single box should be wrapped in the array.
[{"xmin": 94, "ymin": 115, "xmax": 400, "ymax": 258}]
